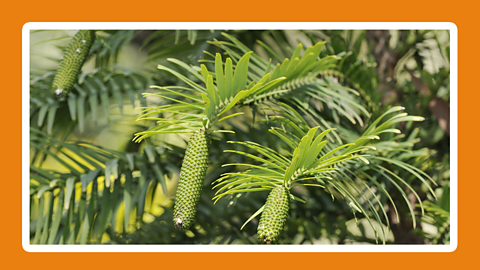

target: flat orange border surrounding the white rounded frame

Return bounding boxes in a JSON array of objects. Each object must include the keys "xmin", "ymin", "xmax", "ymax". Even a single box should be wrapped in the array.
[{"xmin": 7, "ymin": 0, "xmax": 472, "ymax": 269}]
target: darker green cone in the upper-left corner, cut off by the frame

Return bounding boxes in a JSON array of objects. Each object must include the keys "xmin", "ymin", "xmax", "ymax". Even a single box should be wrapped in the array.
[{"xmin": 52, "ymin": 30, "xmax": 95, "ymax": 97}]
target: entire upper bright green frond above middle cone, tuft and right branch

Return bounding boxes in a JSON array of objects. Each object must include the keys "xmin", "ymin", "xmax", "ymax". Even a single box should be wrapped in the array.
[{"xmin": 135, "ymin": 33, "xmax": 368, "ymax": 141}]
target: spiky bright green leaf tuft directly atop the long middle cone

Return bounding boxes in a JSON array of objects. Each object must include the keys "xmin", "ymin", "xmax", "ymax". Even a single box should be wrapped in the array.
[{"xmin": 134, "ymin": 53, "xmax": 284, "ymax": 142}]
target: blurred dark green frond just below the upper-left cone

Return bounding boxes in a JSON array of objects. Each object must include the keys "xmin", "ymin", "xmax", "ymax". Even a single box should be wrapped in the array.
[{"xmin": 30, "ymin": 69, "xmax": 151, "ymax": 134}]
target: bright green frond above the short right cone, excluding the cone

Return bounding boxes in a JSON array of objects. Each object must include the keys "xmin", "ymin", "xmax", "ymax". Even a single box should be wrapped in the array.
[{"xmin": 214, "ymin": 104, "xmax": 431, "ymax": 244}]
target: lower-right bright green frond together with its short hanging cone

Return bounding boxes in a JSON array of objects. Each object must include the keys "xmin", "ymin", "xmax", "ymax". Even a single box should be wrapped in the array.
[{"xmin": 213, "ymin": 107, "xmax": 435, "ymax": 243}]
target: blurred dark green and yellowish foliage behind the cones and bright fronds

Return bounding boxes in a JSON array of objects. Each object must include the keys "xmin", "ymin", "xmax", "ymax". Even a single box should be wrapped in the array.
[{"xmin": 30, "ymin": 30, "xmax": 450, "ymax": 244}]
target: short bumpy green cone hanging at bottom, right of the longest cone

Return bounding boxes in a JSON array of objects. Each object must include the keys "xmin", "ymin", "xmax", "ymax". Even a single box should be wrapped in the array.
[{"xmin": 257, "ymin": 186, "xmax": 290, "ymax": 244}]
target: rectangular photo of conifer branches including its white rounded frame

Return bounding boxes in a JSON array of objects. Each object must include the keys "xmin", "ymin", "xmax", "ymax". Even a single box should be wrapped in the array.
[{"xmin": 26, "ymin": 23, "xmax": 457, "ymax": 249}]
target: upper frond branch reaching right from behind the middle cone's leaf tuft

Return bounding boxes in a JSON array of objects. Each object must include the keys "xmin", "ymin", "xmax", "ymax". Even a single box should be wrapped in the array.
[{"xmin": 204, "ymin": 33, "xmax": 369, "ymax": 125}]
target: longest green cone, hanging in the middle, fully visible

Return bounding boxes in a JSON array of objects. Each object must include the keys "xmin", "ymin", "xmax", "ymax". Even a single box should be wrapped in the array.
[{"xmin": 173, "ymin": 128, "xmax": 210, "ymax": 230}]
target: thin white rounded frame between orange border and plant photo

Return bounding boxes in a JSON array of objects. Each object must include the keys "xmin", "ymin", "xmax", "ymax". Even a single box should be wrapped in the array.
[{"xmin": 22, "ymin": 22, "xmax": 458, "ymax": 252}]
